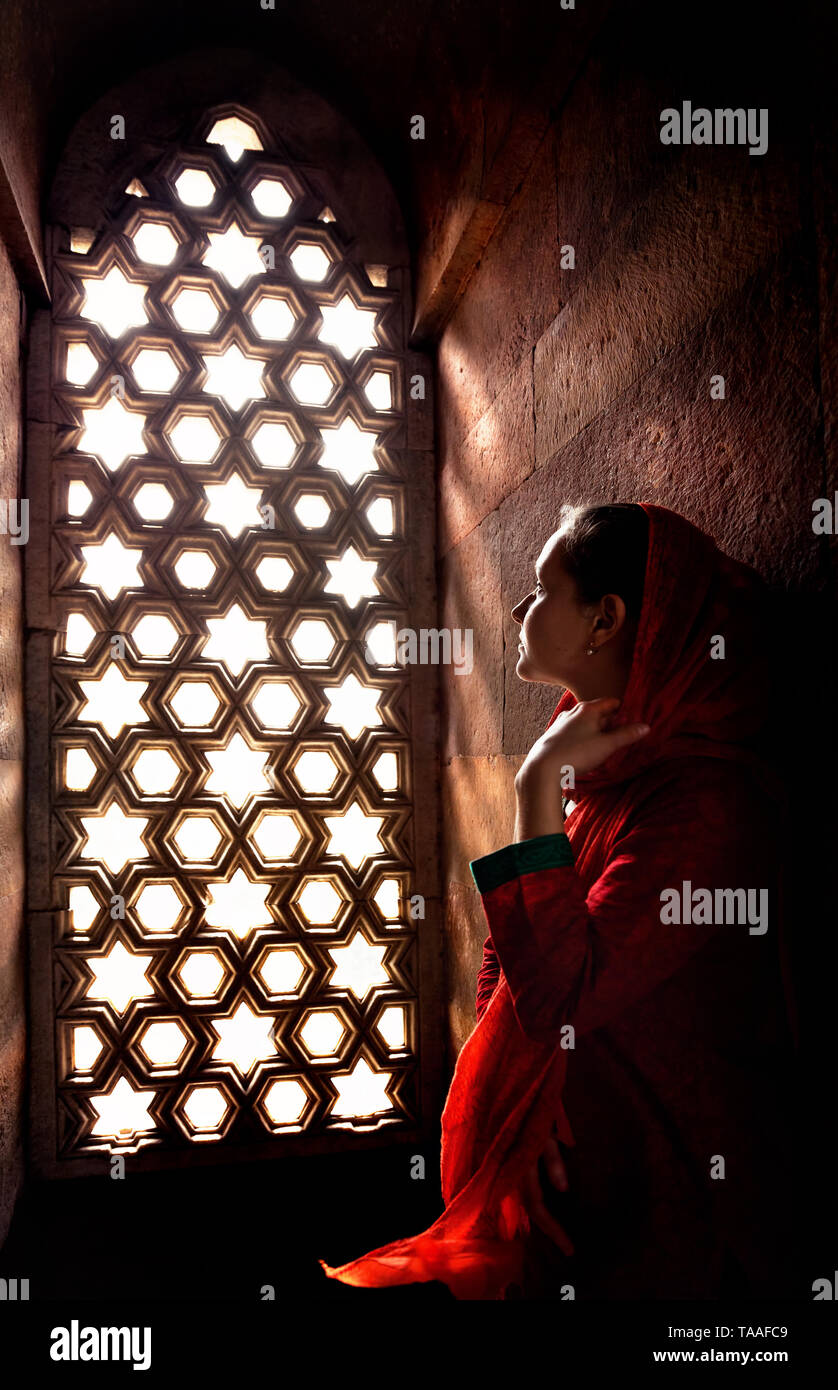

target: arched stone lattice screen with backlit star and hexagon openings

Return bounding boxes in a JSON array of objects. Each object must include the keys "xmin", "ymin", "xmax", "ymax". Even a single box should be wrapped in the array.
[{"xmin": 28, "ymin": 108, "xmax": 421, "ymax": 1161}]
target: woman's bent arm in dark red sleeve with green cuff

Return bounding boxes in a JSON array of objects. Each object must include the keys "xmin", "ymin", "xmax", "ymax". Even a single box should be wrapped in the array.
[{"xmin": 471, "ymin": 765, "xmax": 777, "ymax": 1041}]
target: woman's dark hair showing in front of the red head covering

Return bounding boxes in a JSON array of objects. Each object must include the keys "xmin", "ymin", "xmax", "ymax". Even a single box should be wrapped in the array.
[{"xmin": 559, "ymin": 502, "xmax": 649, "ymax": 620}]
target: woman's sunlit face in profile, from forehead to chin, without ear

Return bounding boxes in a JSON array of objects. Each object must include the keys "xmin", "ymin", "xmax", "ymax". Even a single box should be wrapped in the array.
[{"xmin": 511, "ymin": 531, "xmax": 592, "ymax": 692}]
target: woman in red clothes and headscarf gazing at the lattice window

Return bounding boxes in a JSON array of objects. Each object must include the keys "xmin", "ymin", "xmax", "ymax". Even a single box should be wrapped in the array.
[{"xmin": 321, "ymin": 505, "xmax": 806, "ymax": 1300}]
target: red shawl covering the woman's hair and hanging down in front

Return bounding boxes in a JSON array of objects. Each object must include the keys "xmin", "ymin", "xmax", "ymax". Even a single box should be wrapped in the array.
[{"xmin": 320, "ymin": 505, "xmax": 782, "ymax": 1298}]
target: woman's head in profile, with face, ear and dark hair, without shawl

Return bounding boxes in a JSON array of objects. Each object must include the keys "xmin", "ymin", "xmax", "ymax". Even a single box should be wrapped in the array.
[{"xmin": 511, "ymin": 505, "xmax": 649, "ymax": 701}]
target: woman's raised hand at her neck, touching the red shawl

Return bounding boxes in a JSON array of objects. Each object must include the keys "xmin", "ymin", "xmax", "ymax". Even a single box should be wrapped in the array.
[{"xmin": 516, "ymin": 695, "xmax": 649, "ymax": 790}]
